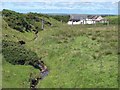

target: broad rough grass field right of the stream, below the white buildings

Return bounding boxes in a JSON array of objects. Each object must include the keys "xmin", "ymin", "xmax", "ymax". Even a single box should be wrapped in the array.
[{"xmin": 35, "ymin": 26, "xmax": 117, "ymax": 88}]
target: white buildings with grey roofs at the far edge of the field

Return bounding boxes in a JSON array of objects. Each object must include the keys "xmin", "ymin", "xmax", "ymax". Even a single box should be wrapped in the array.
[{"xmin": 67, "ymin": 14, "xmax": 107, "ymax": 25}]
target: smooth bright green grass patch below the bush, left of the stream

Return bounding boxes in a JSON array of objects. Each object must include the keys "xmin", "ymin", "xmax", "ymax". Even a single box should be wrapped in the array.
[{"xmin": 2, "ymin": 59, "xmax": 39, "ymax": 88}]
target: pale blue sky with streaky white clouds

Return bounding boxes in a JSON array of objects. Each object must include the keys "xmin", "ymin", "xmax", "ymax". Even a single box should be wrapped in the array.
[{"xmin": 0, "ymin": 0, "xmax": 119, "ymax": 14}]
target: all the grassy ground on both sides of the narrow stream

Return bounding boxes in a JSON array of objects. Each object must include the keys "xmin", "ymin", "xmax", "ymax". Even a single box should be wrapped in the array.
[{"xmin": 3, "ymin": 10, "xmax": 119, "ymax": 88}]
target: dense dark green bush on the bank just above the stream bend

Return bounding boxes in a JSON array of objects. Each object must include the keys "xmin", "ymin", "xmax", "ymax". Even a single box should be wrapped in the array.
[{"xmin": 2, "ymin": 40, "xmax": 39, "ymax": 65}]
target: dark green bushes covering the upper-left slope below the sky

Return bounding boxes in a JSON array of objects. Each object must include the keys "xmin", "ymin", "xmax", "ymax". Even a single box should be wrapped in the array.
[{"xmin": 2, "ymin": 9, "xmax": 61, "ymax": 32}]
